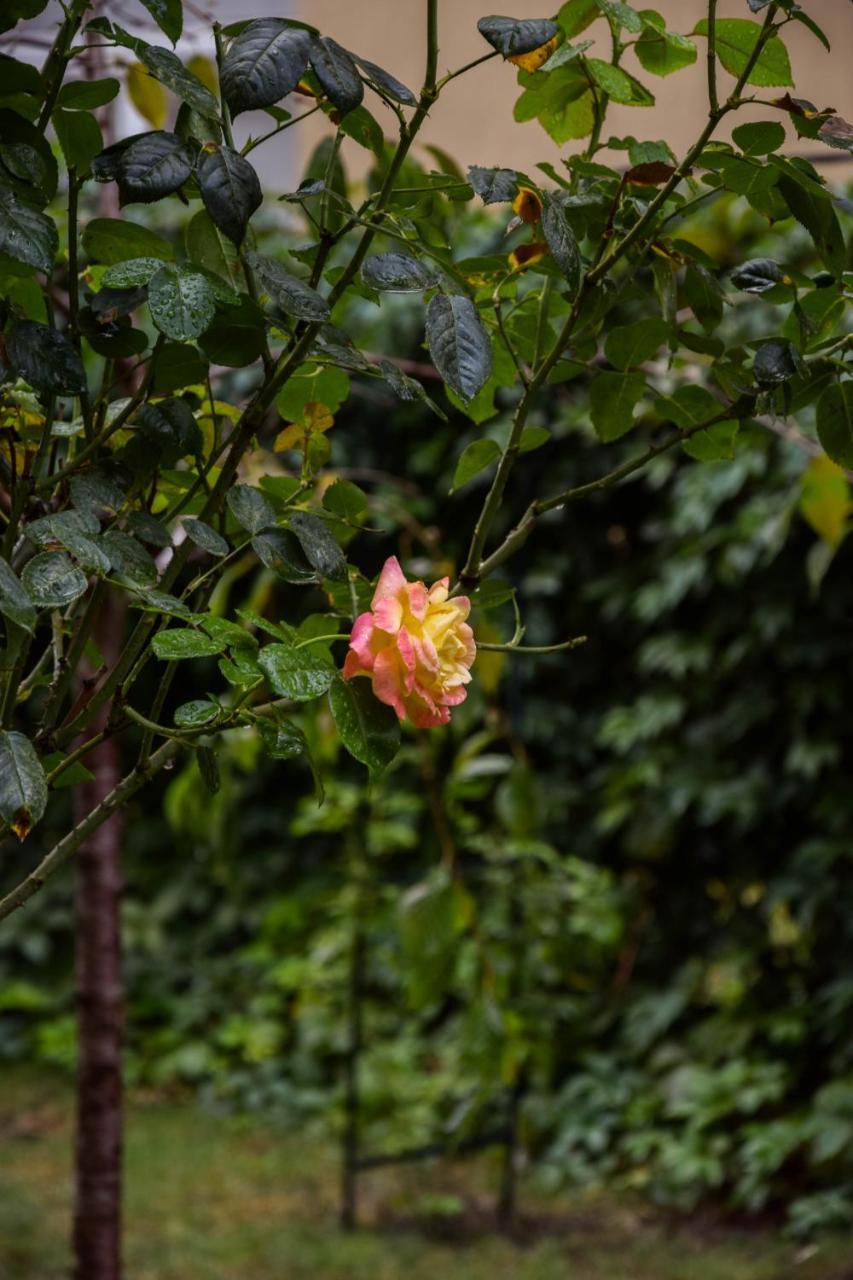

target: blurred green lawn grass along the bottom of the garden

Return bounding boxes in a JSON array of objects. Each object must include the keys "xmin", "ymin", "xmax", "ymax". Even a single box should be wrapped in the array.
[{"xmin": 0, "ymin": 1075, "xmax": 853, "ymax": 1280}]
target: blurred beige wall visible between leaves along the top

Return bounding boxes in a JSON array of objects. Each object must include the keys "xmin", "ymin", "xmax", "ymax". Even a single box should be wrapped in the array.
[{"xmin": 292, "ymin": 0, "xmax": 853, "ymax": 177}]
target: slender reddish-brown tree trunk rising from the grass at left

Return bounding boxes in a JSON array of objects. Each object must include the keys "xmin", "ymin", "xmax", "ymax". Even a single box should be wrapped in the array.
[{"xmin": 73, "ymin": 598, "xmax": 124, "ymax": 1280}]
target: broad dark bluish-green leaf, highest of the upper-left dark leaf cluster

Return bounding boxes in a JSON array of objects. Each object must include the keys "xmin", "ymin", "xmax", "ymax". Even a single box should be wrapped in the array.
[{"xmin": 222, "ymin": 18, "xmax": 311, "ymax": 115}]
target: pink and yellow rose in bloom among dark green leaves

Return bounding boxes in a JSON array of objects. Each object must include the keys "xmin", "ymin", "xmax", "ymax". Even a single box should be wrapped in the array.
[{"xmin": 343, "ymin": 556, "xmax": 476, "ymax": 728}]
